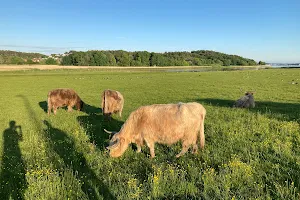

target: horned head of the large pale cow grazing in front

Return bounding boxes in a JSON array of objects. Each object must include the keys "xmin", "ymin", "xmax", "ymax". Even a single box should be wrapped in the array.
[{"xmin": 104, "ymin": 129, "xmax": 129, "ymax": 158}]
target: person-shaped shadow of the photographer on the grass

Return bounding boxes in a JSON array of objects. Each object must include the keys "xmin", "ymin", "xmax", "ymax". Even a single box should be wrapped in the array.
[{"xmin": 0, "ymin": 121, "xmax": 27, "ymax": 199}]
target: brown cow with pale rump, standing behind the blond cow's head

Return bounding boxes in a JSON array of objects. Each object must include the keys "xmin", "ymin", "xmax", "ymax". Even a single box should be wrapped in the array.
[{"xmin": 102, "ymin": 90, "xmax": 124, "ymax": 119}]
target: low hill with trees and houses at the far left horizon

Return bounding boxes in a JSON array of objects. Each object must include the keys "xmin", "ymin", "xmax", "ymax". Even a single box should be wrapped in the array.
[{"xmin": 0, "ymin": 50, "xmax": 58, "ymax": 65}]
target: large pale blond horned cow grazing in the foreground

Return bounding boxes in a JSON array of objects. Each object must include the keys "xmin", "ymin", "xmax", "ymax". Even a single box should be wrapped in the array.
[{"xmin": 105, "ymin": 102, "xmax": 206, "ymax": 158}]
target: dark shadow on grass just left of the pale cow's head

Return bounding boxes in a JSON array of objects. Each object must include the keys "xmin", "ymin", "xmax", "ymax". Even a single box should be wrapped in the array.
[{"xmin": 77, "ymin": 114, "xmax": 124, "ymax": 150}]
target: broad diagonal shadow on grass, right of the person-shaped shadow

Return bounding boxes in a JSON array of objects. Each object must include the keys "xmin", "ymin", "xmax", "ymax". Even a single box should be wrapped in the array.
[{"xmin": 44, "ymin": 120, "xmax": 116, "ymax": 199}]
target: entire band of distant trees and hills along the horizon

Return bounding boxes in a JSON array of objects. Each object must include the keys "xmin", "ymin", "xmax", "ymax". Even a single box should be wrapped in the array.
[{"xmin": 0, "ymin": 50, "xmax": 264, "ymax": 66}]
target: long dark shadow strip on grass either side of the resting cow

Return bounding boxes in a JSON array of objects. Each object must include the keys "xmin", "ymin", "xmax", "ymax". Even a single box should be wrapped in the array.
[{"xmin": 196, "ymin": 98, "xmax": 300, "ymax": 123}]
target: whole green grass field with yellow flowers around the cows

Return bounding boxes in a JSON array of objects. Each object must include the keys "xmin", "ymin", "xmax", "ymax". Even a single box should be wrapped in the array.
[{"xmin": 0, "ymin": 69, "xmax": 300, "ymax": 200}]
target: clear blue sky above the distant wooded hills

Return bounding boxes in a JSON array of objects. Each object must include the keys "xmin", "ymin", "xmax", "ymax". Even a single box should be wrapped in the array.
[{"xmin": 0, "ymin": 0, "xmax": 300, "ymax": 63}]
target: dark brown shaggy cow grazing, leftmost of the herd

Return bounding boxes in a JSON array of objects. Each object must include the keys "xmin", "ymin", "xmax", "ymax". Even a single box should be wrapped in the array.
[{"xmin": 48, "ymin": 88, "xmax": 84, "ymax": 115}]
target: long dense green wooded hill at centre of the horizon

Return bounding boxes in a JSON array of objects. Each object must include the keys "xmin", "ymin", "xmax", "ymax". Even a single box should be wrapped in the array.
[{"xmin": 61, "ymin": 50, "xmax": 257, "ymax": 66}]
